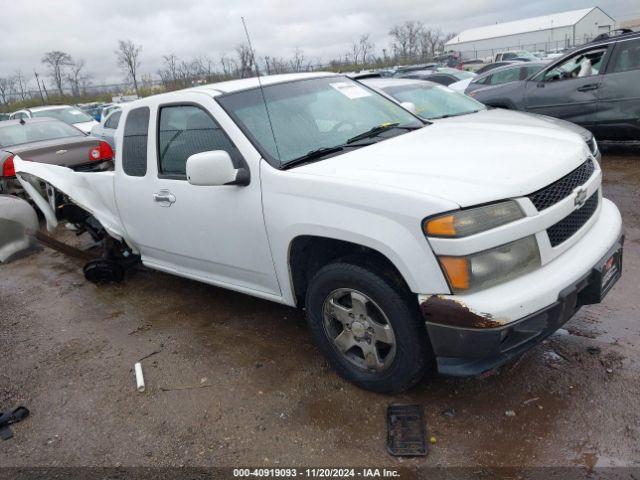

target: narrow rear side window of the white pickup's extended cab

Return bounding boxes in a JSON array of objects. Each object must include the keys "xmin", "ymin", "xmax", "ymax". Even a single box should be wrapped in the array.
[{"xmin": 122, "ymin": 107, "xmax": 149, "ymax": 177}]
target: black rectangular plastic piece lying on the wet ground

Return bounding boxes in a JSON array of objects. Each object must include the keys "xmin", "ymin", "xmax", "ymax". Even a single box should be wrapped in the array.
[{"xmin": 387, "ymin": 405, "xmax": 427, "ymax": 457}]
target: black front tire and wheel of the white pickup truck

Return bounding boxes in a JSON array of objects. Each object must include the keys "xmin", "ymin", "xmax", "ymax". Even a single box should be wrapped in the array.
[{"xmin": 305, "ymin": 263, "xmax": 434, "ymax": 393}]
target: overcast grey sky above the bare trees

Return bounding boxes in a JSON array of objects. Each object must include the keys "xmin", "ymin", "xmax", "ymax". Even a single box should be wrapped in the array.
[{"xmin": 0, "ymin": 0, "xmax": 640, "ymax": 87}]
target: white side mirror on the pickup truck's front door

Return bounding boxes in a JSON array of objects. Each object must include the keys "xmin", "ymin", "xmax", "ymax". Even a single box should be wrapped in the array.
[{"xmin": 187, "ymin": 150, "xmax": 249, "ymax": 187}]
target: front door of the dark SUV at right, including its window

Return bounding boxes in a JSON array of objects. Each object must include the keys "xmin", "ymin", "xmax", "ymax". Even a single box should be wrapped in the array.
[{"xmin": 525, "ymin": 45, "xmax": 610, "ymax": 128}]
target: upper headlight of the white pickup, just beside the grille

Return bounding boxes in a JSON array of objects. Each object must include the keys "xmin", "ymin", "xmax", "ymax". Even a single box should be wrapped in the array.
[{"xmin": 422, "ymin": 200, "xmax": 524, "ymax": 238}]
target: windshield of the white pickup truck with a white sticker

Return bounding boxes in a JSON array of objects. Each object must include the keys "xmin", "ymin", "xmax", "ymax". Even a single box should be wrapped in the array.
[{"xmin": 218, "ymin": 77, "xmax": 423, "ymax": 166}]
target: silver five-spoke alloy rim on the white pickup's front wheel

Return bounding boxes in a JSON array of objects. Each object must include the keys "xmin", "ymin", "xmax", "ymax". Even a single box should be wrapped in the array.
[{"xmin": 323, "ymin": 288, "xmax": 396, "ymax": 372}]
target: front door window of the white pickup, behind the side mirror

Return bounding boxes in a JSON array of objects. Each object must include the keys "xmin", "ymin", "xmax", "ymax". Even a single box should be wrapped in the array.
[{"xmin": 158, "ymin": 105, "xmax": 242, "ymax": 176}]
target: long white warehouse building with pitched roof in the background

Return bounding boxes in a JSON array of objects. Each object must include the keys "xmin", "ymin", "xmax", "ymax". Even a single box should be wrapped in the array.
[{"xmin": 445, "ymin": 7, "xmax": 616, "ymax": 59}]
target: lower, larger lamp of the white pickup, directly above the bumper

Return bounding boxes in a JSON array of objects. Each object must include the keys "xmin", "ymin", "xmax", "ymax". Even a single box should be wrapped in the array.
[{"xmin": 438, "ymin": 235, "xmax": 540, "ymax": 293}]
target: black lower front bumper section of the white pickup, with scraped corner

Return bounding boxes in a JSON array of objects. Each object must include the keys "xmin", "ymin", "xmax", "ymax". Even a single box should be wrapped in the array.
[{"xmin": 423, "ymin": 235, "xmax": 624, "ymax": 376}]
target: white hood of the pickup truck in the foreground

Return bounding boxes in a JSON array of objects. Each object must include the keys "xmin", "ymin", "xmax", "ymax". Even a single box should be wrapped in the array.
[{"xmin": 293, "ymin": 118, "xmax": 589, "ymax": 207}]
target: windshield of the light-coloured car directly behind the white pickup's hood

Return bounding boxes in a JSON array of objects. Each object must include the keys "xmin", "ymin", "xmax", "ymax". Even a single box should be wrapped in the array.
[{"xmin": 382, "ymin": 83, "xmax": 486, "ymax": 120}]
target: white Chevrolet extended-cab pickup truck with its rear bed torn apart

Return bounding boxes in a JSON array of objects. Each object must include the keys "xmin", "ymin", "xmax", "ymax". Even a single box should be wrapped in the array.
[{"xmin": 14, "ymin": 73, "xmax": 623, "ymax": 392}]
